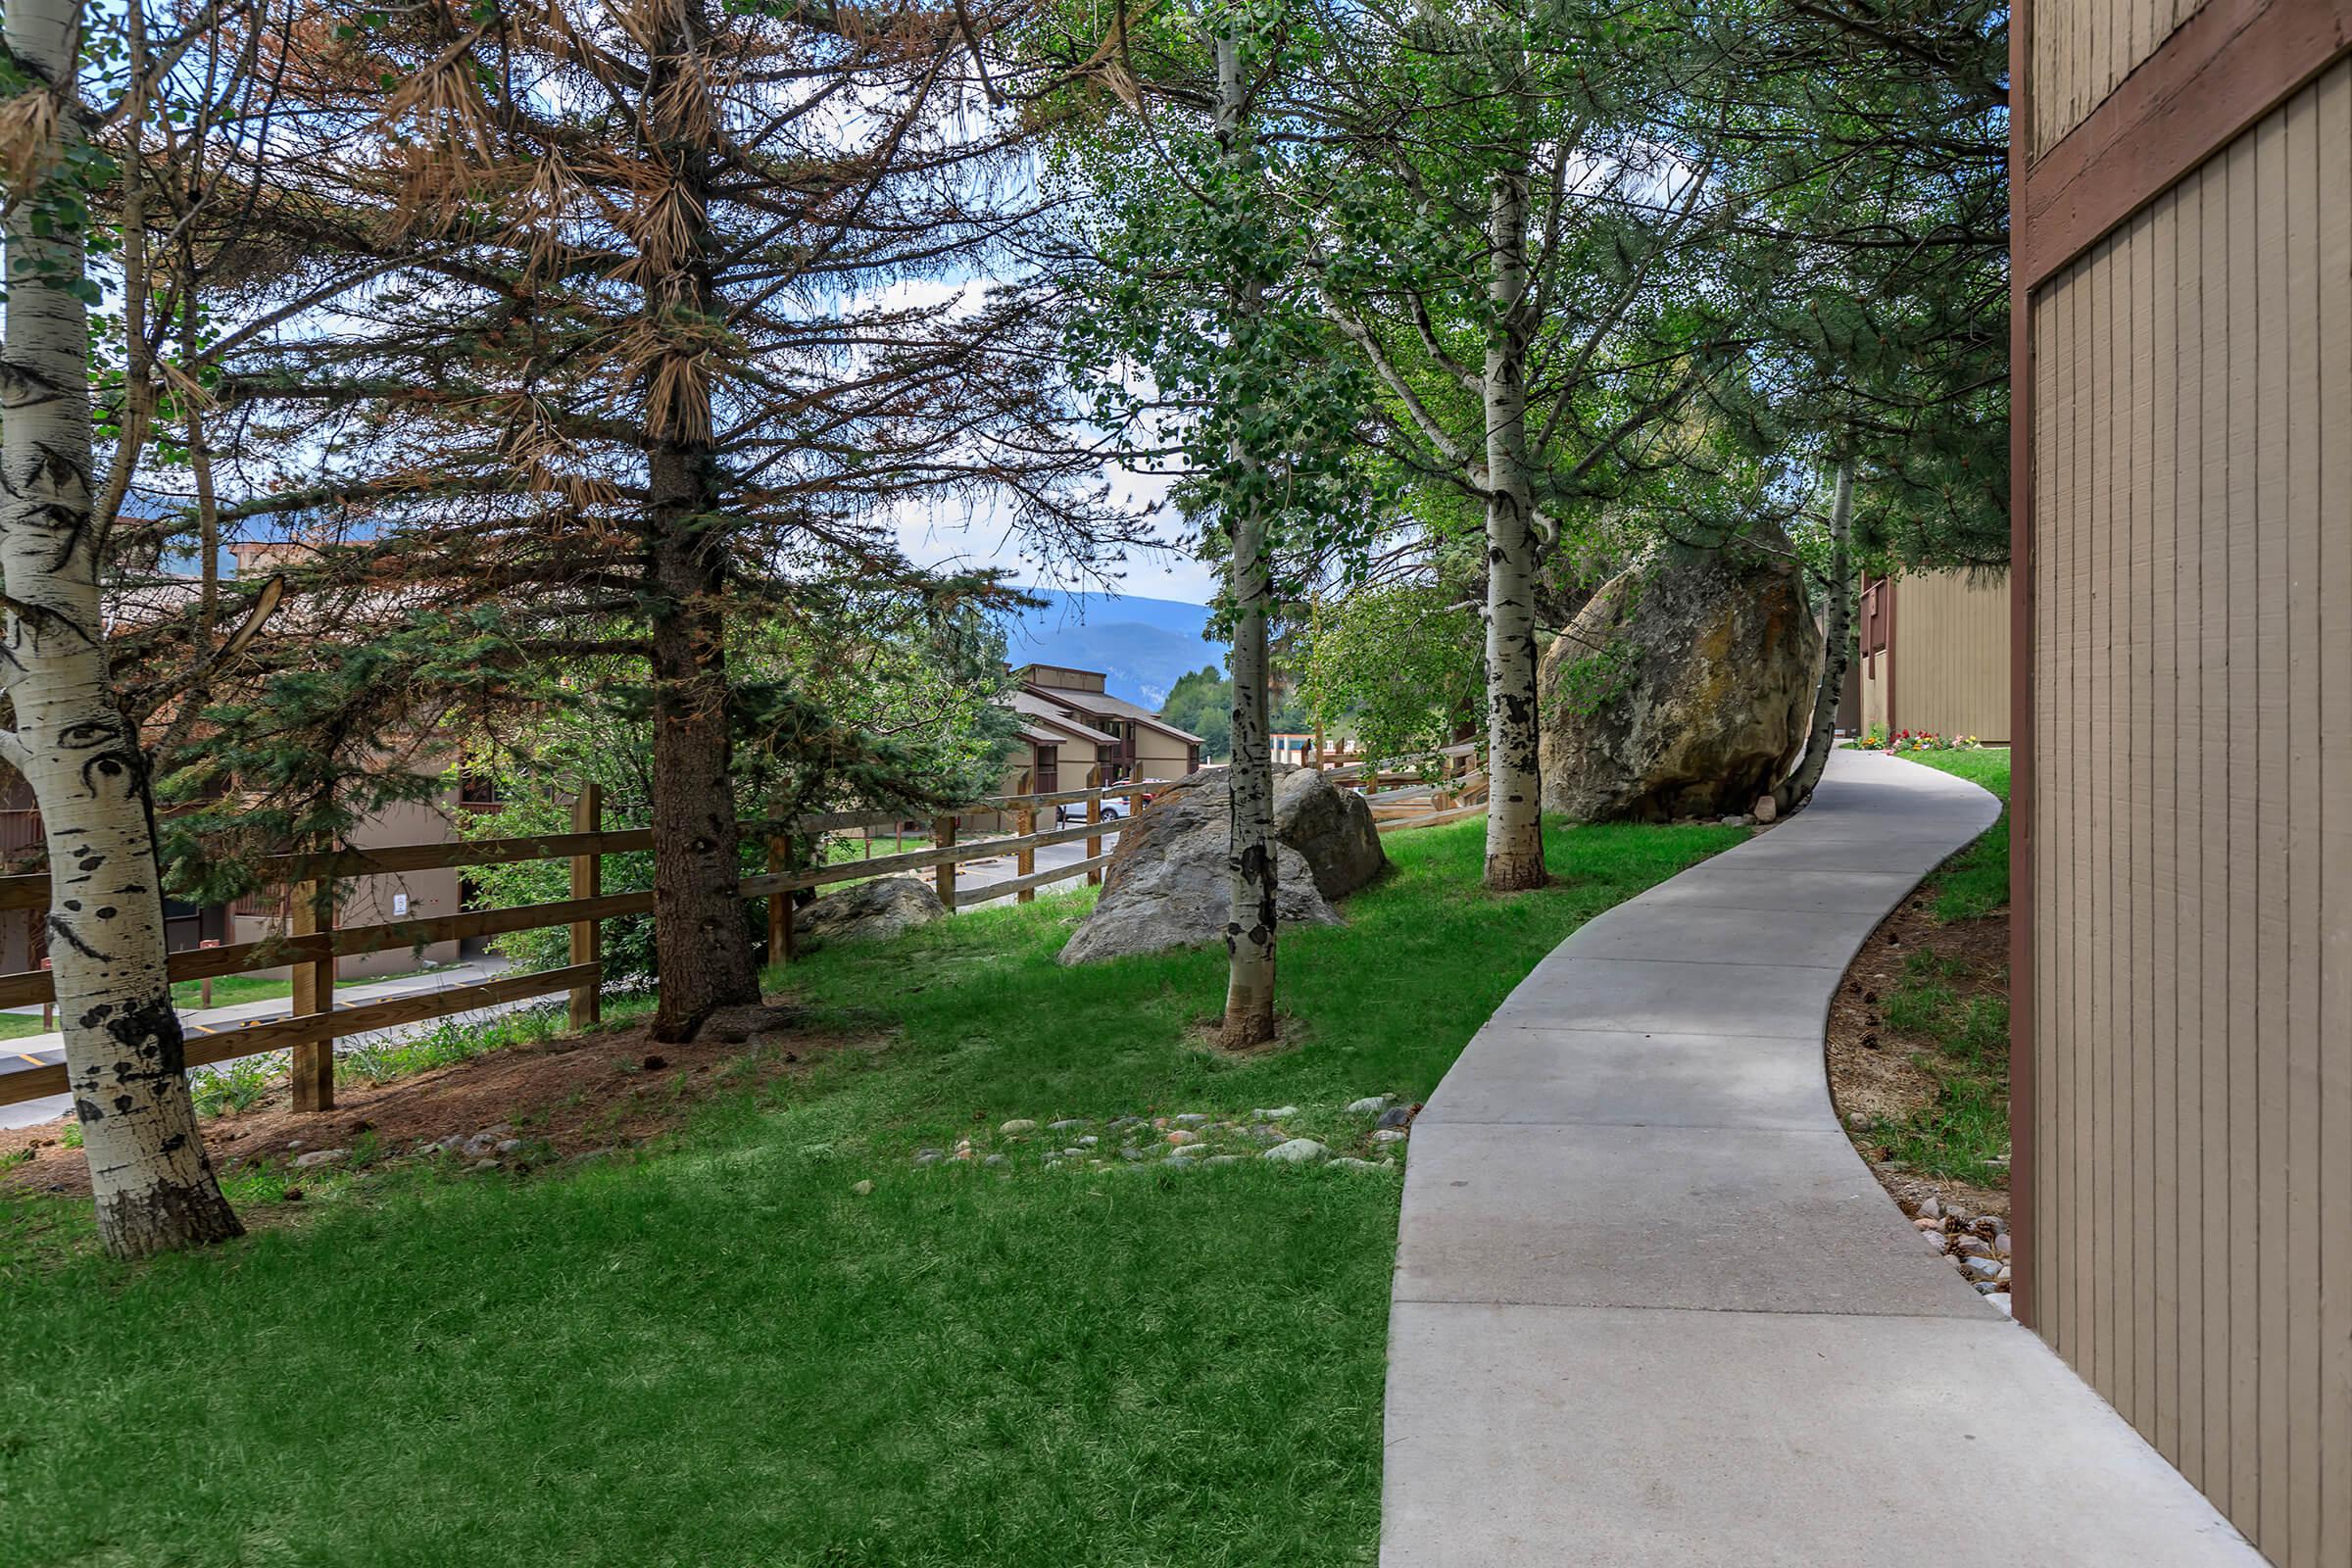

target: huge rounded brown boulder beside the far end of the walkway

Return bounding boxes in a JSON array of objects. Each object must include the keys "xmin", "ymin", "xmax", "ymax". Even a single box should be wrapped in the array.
[{"xmin": 1539, "ymin": 543, "xmax": 1821, "ymax": 823}]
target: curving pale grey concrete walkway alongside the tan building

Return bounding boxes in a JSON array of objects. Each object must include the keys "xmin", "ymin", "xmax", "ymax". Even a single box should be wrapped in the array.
[{"xmin": 1381, "ymin": 753, "xmax": 2263, "ymax": 1568}]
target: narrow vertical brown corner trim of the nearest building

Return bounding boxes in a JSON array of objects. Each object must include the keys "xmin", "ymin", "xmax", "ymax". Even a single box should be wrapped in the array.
[{"xmin": 2009, "ymin": 0, "xmax": 2039, "ymax": 1328}]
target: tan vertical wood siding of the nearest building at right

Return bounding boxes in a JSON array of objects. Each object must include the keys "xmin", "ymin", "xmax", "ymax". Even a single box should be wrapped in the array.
[{"xmin": 2023, "ymin": 55, "xmax": 2352, "ymax": 1568}]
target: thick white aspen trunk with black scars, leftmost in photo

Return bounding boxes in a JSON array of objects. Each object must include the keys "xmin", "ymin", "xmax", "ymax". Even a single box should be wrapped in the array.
[{"xmin": 0, "ymin": 0, "xmax": 240, "ymax": 1257}]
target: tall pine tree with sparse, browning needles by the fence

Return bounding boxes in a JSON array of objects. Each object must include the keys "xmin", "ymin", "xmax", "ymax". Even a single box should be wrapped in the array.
[{"xmin": 223, "ymin": 0, "xmax": 1122, "ymax": 1039}]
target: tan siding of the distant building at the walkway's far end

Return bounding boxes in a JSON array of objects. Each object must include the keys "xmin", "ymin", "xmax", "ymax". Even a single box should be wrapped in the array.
[{"xmin": 1882, "ymin": 571, "xmax": 2011, "ymax": 743}]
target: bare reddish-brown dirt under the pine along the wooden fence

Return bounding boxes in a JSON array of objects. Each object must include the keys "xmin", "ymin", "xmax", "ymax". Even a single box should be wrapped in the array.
[{"xmin": 0, "ymin": 1006, "xmax": 887, "ymax": 1195}]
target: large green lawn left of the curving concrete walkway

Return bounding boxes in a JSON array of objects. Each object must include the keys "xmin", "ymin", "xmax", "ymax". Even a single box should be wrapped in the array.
[{"xmin": 0, "ymin": 820, "xmax": 1745, "ymax": 1568}]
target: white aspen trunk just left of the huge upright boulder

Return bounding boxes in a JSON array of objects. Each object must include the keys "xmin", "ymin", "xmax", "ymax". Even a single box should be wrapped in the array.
[{"xmin": 1484, "ymin": 134, "xmax": 1545, "ymax": 894}]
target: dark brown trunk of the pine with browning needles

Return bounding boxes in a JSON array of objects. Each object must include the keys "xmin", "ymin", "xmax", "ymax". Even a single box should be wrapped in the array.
[{"xmin": 635, "ymin": 0, "xmax": 760, "ymax": 1042}]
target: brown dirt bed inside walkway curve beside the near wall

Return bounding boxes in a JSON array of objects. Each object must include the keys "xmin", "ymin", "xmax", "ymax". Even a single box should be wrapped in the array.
[{"xmin": 1830, "ymin": 891, "xmax": 2009, "ymax": 1222}]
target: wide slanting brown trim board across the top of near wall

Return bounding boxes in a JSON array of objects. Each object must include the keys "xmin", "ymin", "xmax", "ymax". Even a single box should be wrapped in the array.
[{"xmin": 2009, "ymin": 0, "xmax": 2352, "ymax": 286}]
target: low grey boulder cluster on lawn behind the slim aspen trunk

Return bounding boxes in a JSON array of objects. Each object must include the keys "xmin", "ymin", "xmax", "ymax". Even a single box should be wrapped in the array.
[{"xmin": 1060, "ymin": 766, "xmax": 1388, "ymax": 964}]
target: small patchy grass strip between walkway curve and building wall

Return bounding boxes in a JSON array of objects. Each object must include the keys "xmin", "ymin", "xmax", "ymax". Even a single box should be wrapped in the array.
[{"xmin": 1872, "ymin": 748, "xmax": 2009, "ymax": 1187}]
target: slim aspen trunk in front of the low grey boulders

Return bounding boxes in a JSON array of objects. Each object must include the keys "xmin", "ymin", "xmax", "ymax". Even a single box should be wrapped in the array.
[{"xmin": 1216, "ymin": 35, "xmax": 1280, "ymax": 1051}]
